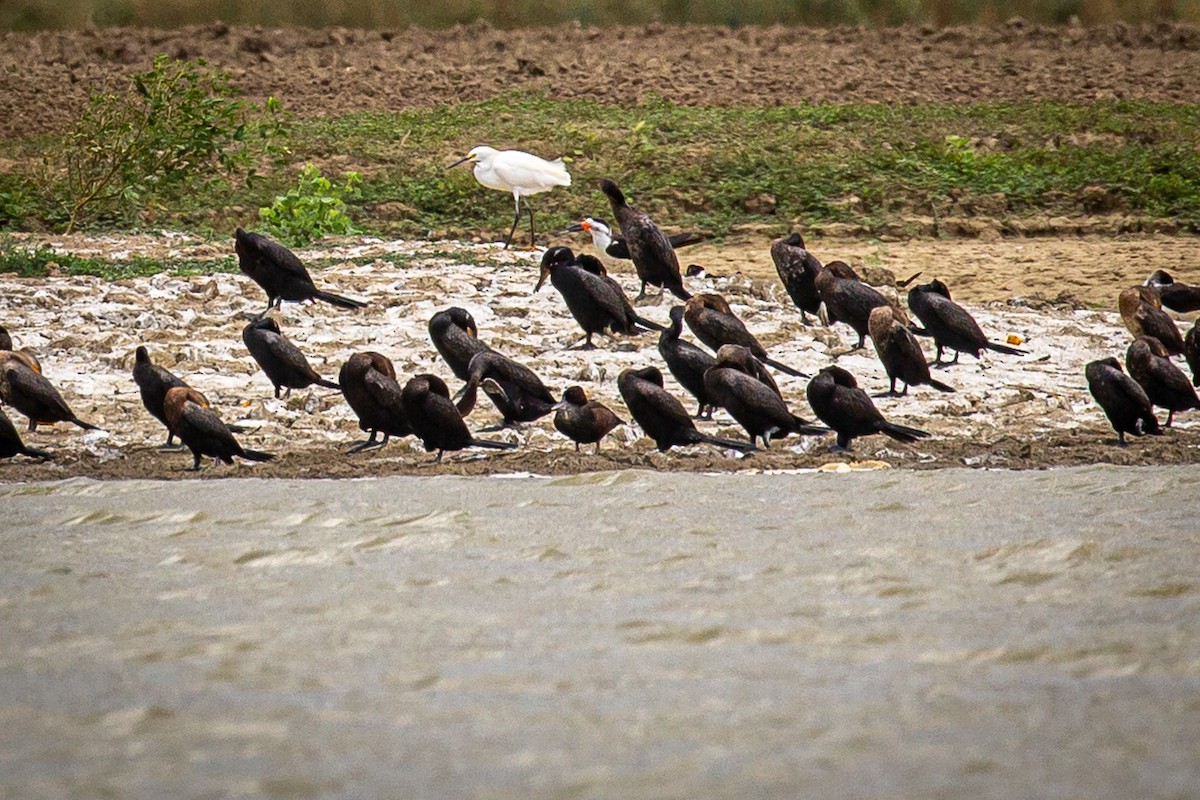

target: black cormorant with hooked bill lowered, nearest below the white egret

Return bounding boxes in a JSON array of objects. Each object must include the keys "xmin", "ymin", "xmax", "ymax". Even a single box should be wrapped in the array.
[{"xmin": 534, "ymin": 247, "xmax": 662, "ymax": 350}]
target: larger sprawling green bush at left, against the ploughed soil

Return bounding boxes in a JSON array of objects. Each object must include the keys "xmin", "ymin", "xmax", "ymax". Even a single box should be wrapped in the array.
[{"xmin": 42, "ymin": 55, "xmax": 288, "ymax": 231}]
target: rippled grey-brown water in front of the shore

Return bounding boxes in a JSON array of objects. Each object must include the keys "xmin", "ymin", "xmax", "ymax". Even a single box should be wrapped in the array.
[{"xmin": 0, "ymin": 468, "xmax": 1200, "ymax": 798}]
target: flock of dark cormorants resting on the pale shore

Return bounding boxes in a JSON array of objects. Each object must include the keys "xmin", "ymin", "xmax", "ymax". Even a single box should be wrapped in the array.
[{"xmin": 0, "ymin": 180, "xmax": 1200, "ymax": 470}]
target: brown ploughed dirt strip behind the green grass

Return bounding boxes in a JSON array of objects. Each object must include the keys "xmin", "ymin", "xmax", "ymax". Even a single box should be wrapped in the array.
[{"xmin": 0, "ymin": 20, "xmax": 1200, "ymax": 137}]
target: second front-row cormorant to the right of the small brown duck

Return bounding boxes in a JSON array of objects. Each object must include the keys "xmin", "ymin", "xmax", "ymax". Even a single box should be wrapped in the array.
[{"xmin": 704, "ymin": 344, "xmax": 828, "ymax": 447}]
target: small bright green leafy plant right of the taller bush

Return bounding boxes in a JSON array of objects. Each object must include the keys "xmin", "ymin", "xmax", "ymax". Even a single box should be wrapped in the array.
[{"xmin": 258, "ymin": 163, "xmax": 362, "ymax": 245}]
